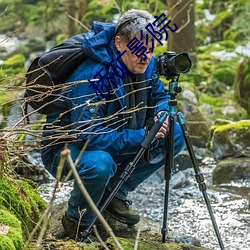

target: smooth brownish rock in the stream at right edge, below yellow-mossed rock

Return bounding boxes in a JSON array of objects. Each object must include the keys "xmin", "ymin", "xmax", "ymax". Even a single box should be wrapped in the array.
[{"xmin": 213, "ymin": 157, "xmax": 250, "ymax": 184}]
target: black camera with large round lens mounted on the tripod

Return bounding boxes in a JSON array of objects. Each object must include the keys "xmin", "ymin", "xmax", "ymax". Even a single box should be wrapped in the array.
[{"xmin": 156, "ymin": 51, "xmax": 192, "ymax": 80}]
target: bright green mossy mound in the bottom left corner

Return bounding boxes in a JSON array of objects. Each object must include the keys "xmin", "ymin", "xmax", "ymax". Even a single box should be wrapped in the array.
[{"xmin": 0, "ymin": 209, "xmax": 24, "ymax": 250}]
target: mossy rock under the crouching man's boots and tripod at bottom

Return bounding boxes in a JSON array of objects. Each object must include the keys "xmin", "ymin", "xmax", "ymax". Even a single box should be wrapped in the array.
[{"xmin": 43, "ymin": 202, "xmax": 209, "ymax": 250}]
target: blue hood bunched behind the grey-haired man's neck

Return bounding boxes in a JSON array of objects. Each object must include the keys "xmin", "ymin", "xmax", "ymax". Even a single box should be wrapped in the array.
[{"xmin": 82, "ymin": 21, "xmax": 116, "ymax": 63}]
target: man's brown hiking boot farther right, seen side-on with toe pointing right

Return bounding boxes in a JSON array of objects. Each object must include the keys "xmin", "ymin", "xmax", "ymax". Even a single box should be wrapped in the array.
[{"xmin": 105, "ymin": 197, "xmax": 140, "ymax": 225}]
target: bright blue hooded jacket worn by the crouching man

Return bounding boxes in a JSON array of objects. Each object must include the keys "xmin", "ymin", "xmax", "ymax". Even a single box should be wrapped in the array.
[{"xmin": 44, "ymin": 22, "xmax": 169, "ymax": 155}]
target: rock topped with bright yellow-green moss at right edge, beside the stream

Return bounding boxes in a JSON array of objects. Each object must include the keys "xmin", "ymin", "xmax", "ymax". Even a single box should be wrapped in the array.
[{"xmin": 209, "ymin": 120, "xmax": 250, "ymax": 160}]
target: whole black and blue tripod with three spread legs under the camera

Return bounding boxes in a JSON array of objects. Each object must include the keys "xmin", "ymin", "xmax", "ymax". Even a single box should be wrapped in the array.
[{"xmin": 82, "ymin": 77, "xmax": 225, "ymax": 250}]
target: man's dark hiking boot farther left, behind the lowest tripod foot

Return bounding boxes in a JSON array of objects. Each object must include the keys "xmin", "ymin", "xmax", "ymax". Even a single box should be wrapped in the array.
[{"xmin": 62, "ymin": 213, "xmax": 97, "ymax": 243}]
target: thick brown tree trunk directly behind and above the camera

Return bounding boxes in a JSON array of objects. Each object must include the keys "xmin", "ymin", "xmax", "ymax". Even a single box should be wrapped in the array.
[{"xmin": 167, "ymin": 0, "xmax": 196, "ymax": 61}]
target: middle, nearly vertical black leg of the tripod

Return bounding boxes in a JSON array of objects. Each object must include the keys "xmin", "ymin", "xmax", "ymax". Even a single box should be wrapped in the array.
[{"xmin": 161, "ymin": 114, "xmax": 175, "ymax": 243}]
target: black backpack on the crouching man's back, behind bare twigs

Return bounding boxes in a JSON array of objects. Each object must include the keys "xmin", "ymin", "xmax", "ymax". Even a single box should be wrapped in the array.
[{"xmin": 24, "ymin": 34, "xmax": 86, "ymax": 114}]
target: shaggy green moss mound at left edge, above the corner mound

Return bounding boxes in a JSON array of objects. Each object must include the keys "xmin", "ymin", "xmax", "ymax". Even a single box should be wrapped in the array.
[{"xmin": 0, "ymin": 174, "xmax": 46, "ymax": 238}]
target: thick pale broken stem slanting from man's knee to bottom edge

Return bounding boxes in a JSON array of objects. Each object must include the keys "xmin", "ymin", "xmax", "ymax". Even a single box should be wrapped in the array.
[{"xmin": 61, "ymin": 149, "xmax": 124, "ymax": 250}]
